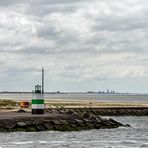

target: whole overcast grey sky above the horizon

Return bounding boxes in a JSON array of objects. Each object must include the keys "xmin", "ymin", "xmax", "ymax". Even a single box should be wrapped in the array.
[{"xmin": 0, "ymin": 0, "xmax": 148, "ymax": 93}]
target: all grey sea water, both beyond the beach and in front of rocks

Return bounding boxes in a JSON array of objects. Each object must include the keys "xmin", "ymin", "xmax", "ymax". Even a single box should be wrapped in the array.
[{"xmin": 0, "ymin": 93, "xmax": 148, "ymax": 148}]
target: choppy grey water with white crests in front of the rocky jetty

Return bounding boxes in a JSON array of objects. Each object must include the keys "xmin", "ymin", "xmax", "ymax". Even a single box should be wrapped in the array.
[{"xmin": 0, "ymin": 117, "xmax": 148, "ymax": 148}]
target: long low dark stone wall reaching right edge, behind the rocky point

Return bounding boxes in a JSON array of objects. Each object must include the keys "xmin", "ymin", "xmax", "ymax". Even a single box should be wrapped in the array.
[{"xmin": 47, "ymin": 107, "xmax": 148, "ymax": 116}]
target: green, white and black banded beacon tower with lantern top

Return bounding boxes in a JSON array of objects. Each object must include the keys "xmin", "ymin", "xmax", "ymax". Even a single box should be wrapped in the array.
[{"xmin": 32, "ymin": 85, "xmax": 44, "ymax": 114}]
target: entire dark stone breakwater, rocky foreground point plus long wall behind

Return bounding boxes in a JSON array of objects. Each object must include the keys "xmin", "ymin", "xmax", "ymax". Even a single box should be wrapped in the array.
[{"xmin": 0, "ymin": 107, "xmax": 148, "ymax": 132}]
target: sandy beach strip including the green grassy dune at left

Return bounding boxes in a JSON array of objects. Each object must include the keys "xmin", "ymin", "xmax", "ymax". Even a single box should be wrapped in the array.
[{"xmin": 0, "ymin": 99, "xmax": 148, "ymax": 109}]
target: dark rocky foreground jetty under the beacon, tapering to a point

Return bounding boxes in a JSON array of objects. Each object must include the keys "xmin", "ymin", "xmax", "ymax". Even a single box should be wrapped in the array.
[{"xmin": 0, "ymin": 109, "xmax": 127, "ymax": 132}]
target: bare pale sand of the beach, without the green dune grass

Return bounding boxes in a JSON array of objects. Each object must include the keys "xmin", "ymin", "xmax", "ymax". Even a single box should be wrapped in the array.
[{"xmin": 0, "ymin": 99, "xmax": 148, "ymax": 112}]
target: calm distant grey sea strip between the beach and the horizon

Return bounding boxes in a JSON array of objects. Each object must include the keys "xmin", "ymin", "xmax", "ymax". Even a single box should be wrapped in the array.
[{"xmin": 0, "ymin": 93, "xmax": 148, "ymax": 103}]
